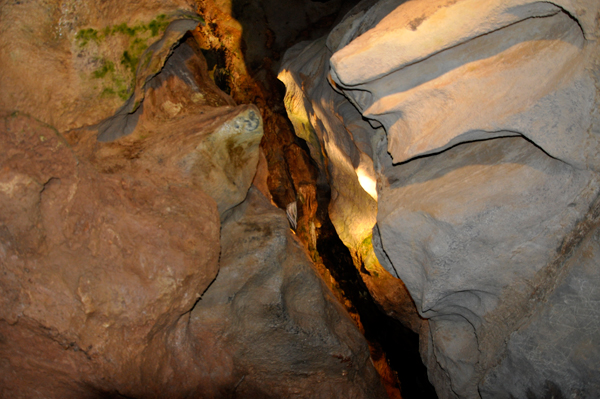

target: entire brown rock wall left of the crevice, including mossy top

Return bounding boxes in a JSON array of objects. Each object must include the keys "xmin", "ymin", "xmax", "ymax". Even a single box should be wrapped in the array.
[{"xmin": 0, "ymin": 1, "xmax": 385, "ymax": 399}]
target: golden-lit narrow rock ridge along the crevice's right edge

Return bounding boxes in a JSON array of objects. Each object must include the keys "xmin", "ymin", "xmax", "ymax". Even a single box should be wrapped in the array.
[{"xmin": 279, "ymin": 33, "xmax": 421, "ymax": 331}]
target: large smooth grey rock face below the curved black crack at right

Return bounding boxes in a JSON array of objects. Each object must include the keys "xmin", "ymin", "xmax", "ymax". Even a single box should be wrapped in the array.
[{"xmin": 378, "ymin": 137, "xmax": 598, "ymax": 397}]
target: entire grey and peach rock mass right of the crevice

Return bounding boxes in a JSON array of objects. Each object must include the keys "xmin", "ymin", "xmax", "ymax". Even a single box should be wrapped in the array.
[{"xmin": 280, "ymin": 0, "xmax": 600, "ymax": 398}]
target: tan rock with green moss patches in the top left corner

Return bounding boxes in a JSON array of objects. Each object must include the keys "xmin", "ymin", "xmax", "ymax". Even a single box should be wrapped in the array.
[{"xmin": 0, "ymin": 0, "xmax": 199, "ymax": 131}]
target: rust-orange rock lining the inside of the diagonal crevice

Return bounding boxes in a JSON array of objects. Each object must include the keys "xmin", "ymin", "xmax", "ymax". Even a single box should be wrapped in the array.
[{"xmin": 195, "ymin": 4, "xmax": 408, "ymax": 397}]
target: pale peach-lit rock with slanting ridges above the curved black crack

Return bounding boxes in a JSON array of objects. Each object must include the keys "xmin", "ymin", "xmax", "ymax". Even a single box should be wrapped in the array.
[{"xmin": 331, "ymin": 1, "xmax": 600, "ymax": 168}]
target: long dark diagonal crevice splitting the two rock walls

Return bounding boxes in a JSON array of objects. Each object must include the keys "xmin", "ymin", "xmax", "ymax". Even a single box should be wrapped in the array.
[{"xmin": 199, "ymin": 0, "xmax": 437, "ymax": 399}]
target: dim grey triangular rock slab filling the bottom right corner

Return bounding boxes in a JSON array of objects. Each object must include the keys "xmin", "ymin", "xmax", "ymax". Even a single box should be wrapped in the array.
[{"xmin": 479, "ymin": 219, "xmax": 600, "ymax": 398}]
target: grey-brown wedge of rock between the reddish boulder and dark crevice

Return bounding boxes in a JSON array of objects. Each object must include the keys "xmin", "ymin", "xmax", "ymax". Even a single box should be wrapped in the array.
[{"xmin": 189, "ymin": 187, "xmax": 386, "ymax": 399}]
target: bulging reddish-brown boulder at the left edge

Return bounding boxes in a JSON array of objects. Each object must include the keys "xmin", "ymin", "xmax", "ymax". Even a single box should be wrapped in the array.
[{"xmin": 0, "ymin": 114, "xmax": 219, "ymax": 397}]
